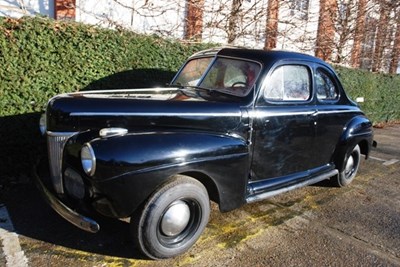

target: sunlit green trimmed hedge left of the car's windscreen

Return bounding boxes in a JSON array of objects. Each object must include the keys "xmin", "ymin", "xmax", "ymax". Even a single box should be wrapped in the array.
[{"xmin": 0, "ymin": 17, "xmax": 209, "ymax": 116}]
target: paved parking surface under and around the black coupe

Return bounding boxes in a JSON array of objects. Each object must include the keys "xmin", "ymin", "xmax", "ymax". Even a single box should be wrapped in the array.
[{"xmin": 0, "ymin": 125, "xmax": 400, "ymax": 266}]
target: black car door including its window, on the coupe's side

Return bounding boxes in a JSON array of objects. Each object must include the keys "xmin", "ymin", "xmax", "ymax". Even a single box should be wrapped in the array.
[{"xmin": 252, "ymin": 63, "xmax": 316, "ymax": 180}]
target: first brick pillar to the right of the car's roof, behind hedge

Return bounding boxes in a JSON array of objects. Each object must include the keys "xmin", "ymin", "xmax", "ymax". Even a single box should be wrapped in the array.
[{"xmin": 351, "ymin": 0, "xmax": 367, "ymax": 68}]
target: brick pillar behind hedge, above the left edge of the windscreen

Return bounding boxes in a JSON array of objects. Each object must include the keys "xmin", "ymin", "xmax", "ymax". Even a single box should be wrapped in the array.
[{"xmin": 185, "ymin": 0, "xmax": 204, "ymax": 41}]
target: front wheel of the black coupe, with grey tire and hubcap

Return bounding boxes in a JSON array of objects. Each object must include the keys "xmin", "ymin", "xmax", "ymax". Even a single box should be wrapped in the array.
[{"xmin": 131, "ymin": 176, "xmax": 210, "ymax": 259}]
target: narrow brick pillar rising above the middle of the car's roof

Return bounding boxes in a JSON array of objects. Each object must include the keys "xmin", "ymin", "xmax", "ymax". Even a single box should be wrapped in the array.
[{"xmin": 264, "ymin": 0, "xmax": 279, "ymax": 50}]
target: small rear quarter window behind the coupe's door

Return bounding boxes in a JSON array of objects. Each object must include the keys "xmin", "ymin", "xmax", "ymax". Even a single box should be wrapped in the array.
[{"xmin": 315, "ymin": 69, "xmax": 339, "ymax": 100}]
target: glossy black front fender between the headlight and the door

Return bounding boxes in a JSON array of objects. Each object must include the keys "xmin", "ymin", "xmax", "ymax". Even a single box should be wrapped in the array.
[{"xmin": 83, "ymin": 132, "xmax": 249, "ymax": 217}]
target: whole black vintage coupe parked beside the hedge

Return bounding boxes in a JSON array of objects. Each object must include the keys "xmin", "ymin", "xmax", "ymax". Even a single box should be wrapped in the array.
[{"xmin": 37, "ymin": 48, "xmax": 373, "ymax": 259}]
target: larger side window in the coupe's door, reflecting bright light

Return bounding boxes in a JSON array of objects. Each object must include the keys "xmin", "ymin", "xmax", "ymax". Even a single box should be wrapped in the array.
[{"xmin": 264, "ymin": 65, "xmax": 311, "ymax": 101}]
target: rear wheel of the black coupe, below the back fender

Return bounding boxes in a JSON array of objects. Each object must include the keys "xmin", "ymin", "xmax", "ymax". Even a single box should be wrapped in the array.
[{"xmin": 334, "ymin": 145, "xmax": 361, "ymax": 187}]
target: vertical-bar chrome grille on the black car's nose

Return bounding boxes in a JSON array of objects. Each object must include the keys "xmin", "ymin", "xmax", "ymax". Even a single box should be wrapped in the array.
[{"xmin": 47, "ymin": 131, "xmax": 75, "ymax": 194}]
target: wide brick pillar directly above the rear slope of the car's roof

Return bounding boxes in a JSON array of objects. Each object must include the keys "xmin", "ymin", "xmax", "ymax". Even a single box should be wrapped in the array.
[{"xmin": 315, "ymin": 0, "xmax": 337, "ymax": 60}]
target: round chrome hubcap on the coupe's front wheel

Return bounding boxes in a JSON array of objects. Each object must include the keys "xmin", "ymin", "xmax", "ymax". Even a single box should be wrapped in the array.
[{"xmin": 161, "ymin": 200, "xmax": 190, "ymax": 236}]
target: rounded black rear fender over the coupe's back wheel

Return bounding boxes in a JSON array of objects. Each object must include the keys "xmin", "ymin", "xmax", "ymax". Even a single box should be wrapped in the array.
[{"xmin": 334, "ymin": 115, "xmax": 373, "ymax": 171}]
